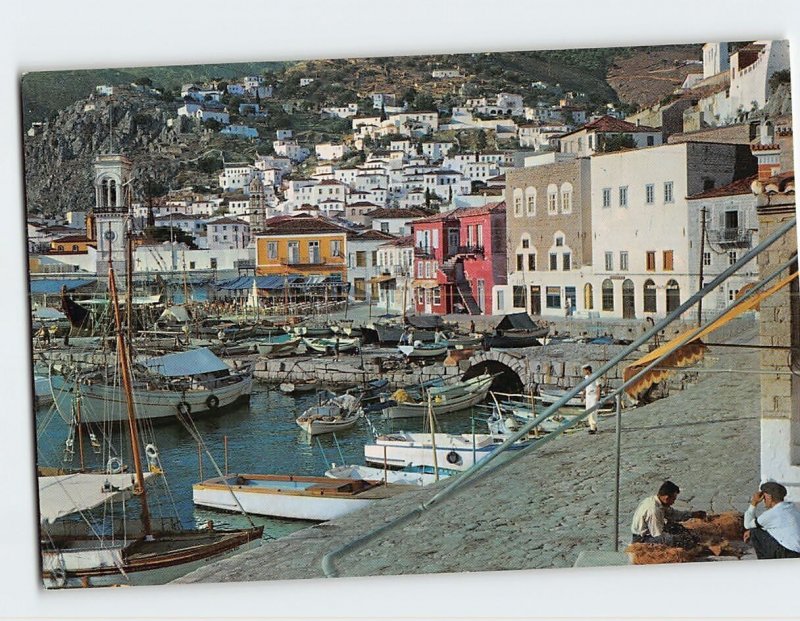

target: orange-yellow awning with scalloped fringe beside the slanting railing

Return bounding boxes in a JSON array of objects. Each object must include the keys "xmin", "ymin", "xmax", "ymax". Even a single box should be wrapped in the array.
[{"xmin": 622, "ymin": 272, "xmax": 797, "ymax": 398}]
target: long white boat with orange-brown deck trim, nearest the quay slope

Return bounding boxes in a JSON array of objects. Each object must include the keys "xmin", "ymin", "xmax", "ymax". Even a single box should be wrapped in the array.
[{"xmin": 192, "ymin": 474, "xmax": 411, "ymax": 522}]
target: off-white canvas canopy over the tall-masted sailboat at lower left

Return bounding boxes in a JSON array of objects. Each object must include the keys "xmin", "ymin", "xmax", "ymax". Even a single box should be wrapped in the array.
[{"xmin": 39, "ymin": 472, "xmax": 155, "ymax": 522}]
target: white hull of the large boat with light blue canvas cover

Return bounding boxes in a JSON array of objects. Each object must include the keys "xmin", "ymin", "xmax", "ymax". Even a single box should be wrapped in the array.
[{"xmin": 51, "ymin": 375, "xmax": 253, "ymax": 423}]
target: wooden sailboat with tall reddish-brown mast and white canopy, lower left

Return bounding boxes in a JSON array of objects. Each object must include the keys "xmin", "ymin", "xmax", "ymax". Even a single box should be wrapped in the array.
[{"xmin": 39, "ymin": 265, "xmax": 263, "ymax": 588}]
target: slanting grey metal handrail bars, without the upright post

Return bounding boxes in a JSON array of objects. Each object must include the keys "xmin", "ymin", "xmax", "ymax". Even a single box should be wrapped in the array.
[{"xmin": 322, "ymin": 218, "xmax": 796, "ymax": 578}]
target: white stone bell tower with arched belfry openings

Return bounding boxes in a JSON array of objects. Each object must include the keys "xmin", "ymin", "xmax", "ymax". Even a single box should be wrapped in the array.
[{"xmin": 93, "ymin": 153, "xmax": 133, "ymax": 275}]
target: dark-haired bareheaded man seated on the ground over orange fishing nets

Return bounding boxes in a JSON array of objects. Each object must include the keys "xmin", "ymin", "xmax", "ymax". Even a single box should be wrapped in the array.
[{"xmin": 631, "ymin": 481, "xmax": 706, "ymax": 549}]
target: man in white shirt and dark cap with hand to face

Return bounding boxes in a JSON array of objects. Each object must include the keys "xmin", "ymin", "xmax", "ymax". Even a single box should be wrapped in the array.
[{"xmin": 744, "ymin": 481, "xmax": 800, "ymax": 559}]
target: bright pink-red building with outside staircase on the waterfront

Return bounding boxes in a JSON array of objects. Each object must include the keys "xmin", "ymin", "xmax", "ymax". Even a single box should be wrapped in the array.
[{"xmin": 412, "ymin": 202, "xmax": 506, "ymax": 315}]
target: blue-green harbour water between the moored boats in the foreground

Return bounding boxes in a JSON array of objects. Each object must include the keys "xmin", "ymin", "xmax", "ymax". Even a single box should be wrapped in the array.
[{"xmin": 37, "ymin": 382, "xmax": 488, "ymax": 538}]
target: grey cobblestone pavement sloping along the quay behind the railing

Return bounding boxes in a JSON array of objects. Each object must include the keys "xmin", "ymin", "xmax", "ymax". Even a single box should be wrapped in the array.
[{"xmin": 180, "ymin": 348, "xmax": 759, "ymax": 582}]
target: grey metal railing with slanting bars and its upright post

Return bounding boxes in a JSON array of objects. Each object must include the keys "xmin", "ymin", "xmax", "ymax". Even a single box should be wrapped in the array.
[{"xmin": 322, "ymin": 218, "xmax": 797, "ymax": 578}]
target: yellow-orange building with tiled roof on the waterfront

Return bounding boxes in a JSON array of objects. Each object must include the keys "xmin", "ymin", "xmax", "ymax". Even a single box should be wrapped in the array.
[{"xmin": 254, "ymin": 215, "xmax": 347, "ymax": 281}]
